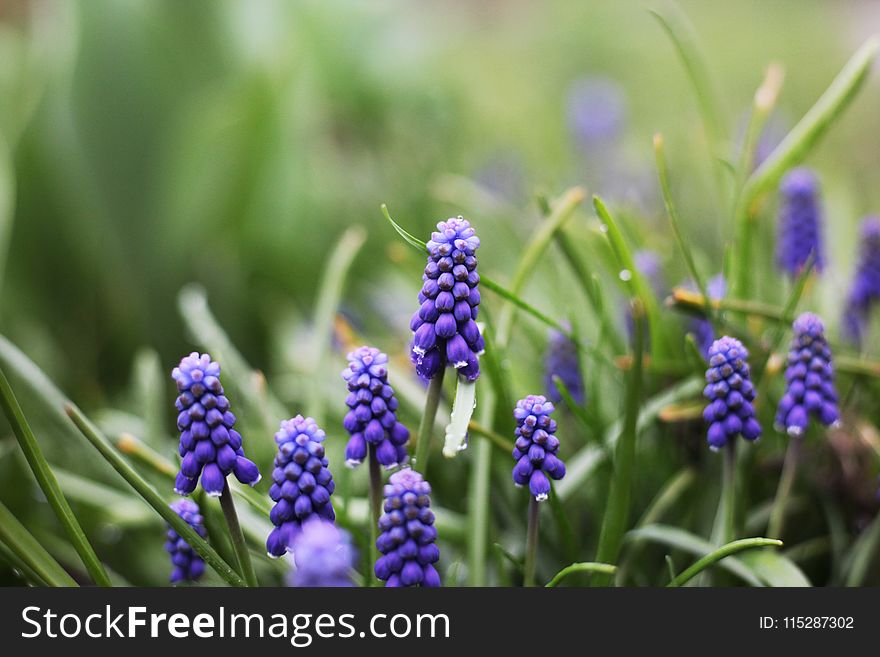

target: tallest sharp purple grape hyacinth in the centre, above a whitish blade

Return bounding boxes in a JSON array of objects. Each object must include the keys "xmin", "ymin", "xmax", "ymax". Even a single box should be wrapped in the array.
[{"xmin": 410, "ymin": 217, "xmax": 485, "ymax": 381}]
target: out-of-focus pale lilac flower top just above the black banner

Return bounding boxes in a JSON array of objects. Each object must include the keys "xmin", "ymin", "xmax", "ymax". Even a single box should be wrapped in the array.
[{"xmin": 288, "ymin": 518, "xmax": 357, "ymax": 587}]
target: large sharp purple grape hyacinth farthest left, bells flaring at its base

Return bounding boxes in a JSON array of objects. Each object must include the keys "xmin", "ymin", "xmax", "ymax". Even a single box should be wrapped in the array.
[{"xmin": 171, "ymin": 351, "xmax": 260, "ymax": 497}]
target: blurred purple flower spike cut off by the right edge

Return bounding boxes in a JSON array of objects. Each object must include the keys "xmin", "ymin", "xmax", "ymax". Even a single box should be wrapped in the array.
[{"xmin": 843, "ymin": 216, "xmax": 880, "ymax": 345}]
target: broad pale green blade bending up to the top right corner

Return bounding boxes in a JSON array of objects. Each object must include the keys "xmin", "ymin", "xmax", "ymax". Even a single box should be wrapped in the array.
[{"xmin": 731, "ymin": 36, "xmax": 880, "ymax": 297}]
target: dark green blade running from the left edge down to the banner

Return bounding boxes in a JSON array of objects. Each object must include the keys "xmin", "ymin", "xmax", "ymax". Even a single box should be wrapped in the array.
[{"xmin": 0, "ymin": 369, "xmax": 111, "ymax": 586}]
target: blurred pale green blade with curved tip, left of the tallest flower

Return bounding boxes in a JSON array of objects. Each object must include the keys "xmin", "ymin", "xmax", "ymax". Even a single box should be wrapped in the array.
[{"xmin": 308, "ymin": 226, "xmax": 367, "ymax": 425}]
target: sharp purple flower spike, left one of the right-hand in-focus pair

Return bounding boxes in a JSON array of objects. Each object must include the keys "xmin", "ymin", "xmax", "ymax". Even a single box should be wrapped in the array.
[{"xmin": 703, "ymin": 335, "xmax": 761, "ymax": 450}]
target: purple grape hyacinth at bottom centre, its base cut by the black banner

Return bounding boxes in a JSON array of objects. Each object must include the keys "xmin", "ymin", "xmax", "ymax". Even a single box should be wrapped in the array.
[{"xmin": 375, "ymin": 468, "xmax": 440, "ymax": 587}]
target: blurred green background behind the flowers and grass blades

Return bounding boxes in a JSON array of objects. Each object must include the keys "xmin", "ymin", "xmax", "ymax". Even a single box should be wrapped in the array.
[{"xmin": 0, "ymin": 0, "xmax": 880, "ymax": 583}]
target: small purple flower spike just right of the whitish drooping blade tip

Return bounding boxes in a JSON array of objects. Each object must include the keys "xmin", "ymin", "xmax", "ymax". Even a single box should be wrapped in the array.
[{"xmin": 513, "ymin": 395, "xmax": 565, "ymax": 502}]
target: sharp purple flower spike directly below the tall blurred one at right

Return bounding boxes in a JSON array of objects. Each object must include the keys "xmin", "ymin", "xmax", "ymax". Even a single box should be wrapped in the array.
[{"xmin": 776, "ymin": 313, "xmax": 840, "ymax": 436}]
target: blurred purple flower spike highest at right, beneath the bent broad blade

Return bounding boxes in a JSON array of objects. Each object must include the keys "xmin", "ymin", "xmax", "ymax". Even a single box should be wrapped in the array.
[{"xmin": 776, "ymin": 167, "xmax": 825, "ymax": 276}]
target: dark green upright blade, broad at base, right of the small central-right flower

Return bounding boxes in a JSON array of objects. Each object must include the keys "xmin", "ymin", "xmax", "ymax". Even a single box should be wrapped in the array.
[{"xmin": 593, "ymin": 299, "xmax": 645, "ymax": 586}]
